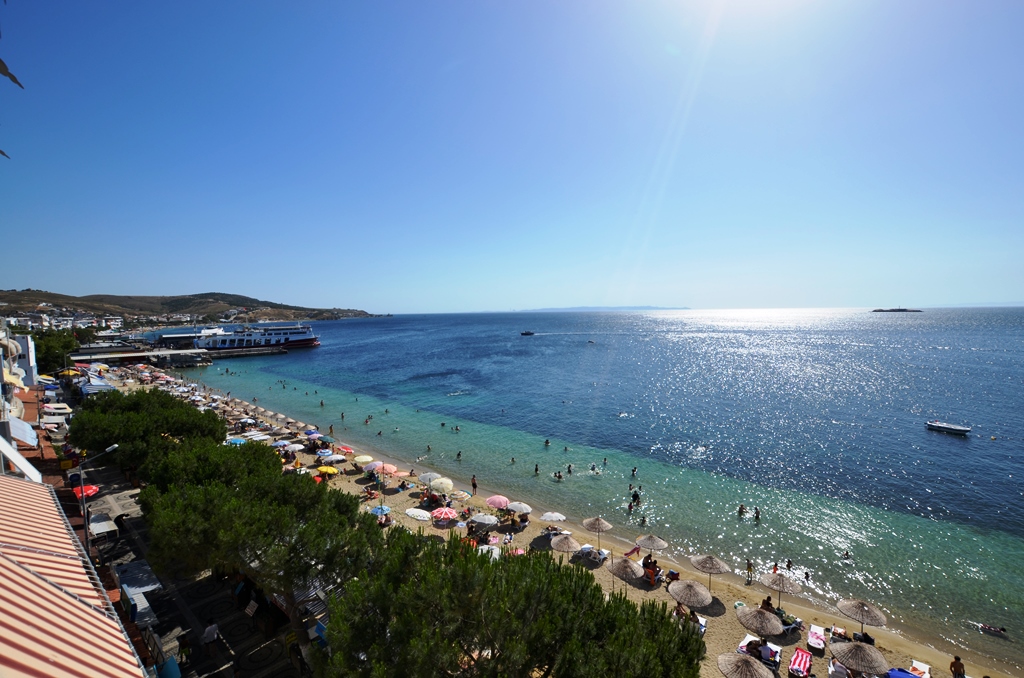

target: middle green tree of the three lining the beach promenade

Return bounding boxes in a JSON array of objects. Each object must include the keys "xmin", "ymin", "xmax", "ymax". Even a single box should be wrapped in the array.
[{"xmin": 142, "ymin": 450, "xmax": 382, "ymax": 630}]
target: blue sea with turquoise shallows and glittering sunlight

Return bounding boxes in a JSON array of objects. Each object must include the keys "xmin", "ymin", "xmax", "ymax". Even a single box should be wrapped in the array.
[{"xmin": 185, "ymin": 308, "xmax": 1024, "ymax": 669}]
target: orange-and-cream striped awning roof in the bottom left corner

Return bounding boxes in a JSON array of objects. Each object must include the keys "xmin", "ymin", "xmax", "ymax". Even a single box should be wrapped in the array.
[{"xmin": 0, "ymin": 476, "xmax": 144, "ymax": 678}]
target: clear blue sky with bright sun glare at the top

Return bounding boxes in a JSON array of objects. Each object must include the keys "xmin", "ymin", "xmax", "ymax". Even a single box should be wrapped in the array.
[{"xmin": 0, "ymin": 0, "xmax": 1024, "ymax": 313}]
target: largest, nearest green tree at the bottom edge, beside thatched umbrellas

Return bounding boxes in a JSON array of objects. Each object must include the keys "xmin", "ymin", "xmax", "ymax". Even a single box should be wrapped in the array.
[{"xmin": 317, "ymin": 529, "xmax": 705, "ymax": 678}]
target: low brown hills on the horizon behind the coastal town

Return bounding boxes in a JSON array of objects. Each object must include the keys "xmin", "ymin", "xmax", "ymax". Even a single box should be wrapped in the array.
[{"xmin": 0, "ymin": 289, "xmax": 370, "ymax": 321}]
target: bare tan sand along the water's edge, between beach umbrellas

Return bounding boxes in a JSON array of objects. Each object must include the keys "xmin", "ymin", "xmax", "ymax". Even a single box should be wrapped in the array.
[{"xmin": 119, "ymin": 374, "xmax": 1017, "ymax": 678}]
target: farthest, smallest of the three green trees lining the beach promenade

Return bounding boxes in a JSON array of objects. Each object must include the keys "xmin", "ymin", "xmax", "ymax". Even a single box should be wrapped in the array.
[{"xmin": 69, "ymin": 389, "xmax": 227, "ymax": 478}]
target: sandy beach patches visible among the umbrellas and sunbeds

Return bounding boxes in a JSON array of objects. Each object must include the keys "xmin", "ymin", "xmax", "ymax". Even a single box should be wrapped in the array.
[{"xmin": 108, "ymin": 374, "xmax": 1015, "ymax": 678}]
